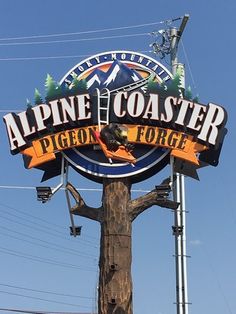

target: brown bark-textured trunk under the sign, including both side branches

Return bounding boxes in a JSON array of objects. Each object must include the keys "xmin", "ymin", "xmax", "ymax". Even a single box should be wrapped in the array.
[{"xmin": 66, "ymin": 178, "xmax": 178, "ymax": 314}]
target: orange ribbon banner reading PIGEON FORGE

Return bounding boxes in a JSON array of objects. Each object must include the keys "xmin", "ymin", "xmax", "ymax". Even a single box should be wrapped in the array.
[{"xmin": 21, "ymin": 125, "xmax": 208, "ymax": 168}]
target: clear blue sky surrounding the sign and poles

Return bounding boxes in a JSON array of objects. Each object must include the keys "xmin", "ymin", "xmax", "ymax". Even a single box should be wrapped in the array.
[{"xmin": 0, "ymin": 0, "xmax": 236, "ymax": 314}]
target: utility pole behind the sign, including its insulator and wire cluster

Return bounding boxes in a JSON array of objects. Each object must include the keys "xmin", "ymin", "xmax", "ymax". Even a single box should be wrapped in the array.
[{"xmin": 150, "ymin": 14, "xmax": 189, "ymax": 314}]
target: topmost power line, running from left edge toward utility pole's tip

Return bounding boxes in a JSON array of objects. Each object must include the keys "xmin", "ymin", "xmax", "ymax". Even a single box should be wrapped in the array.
[{"xmin": 0, "ymin": 17, "xmax": 182, "ymax": 41}]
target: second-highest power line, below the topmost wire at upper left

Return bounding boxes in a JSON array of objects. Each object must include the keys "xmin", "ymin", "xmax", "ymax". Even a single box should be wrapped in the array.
[{"xmin": 0, "ymin": 33, "xmax": 150, "ymax": 47}]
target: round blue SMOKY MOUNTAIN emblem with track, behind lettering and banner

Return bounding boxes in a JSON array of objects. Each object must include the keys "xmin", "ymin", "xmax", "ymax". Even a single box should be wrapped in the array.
[{"xmin": 61, "ymin": 51, "xmax": 172, "ymax": 182}]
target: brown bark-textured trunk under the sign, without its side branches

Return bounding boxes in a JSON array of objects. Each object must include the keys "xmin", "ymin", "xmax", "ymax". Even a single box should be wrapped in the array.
[{"xmin": 98, "ymin": 179, "xmax": 133, "ymax": 314}]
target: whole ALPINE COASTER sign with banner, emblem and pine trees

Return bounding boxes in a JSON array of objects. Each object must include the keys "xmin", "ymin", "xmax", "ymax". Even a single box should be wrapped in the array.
[{"xmin": 1, "ymin": 51, "xmax": 226, "ymax": 182}]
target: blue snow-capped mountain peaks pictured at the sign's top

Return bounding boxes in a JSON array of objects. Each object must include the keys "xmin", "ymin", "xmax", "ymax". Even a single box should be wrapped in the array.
[{"xmin": 86, "ymin": 60, "xmax": 142, "ymax": 92}]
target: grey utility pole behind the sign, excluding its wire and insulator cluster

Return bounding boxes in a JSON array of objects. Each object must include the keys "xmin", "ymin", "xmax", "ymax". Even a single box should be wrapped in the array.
[{"xmin": 170, "ymin": 15, "xmax": 189, "ymax": 314}]
